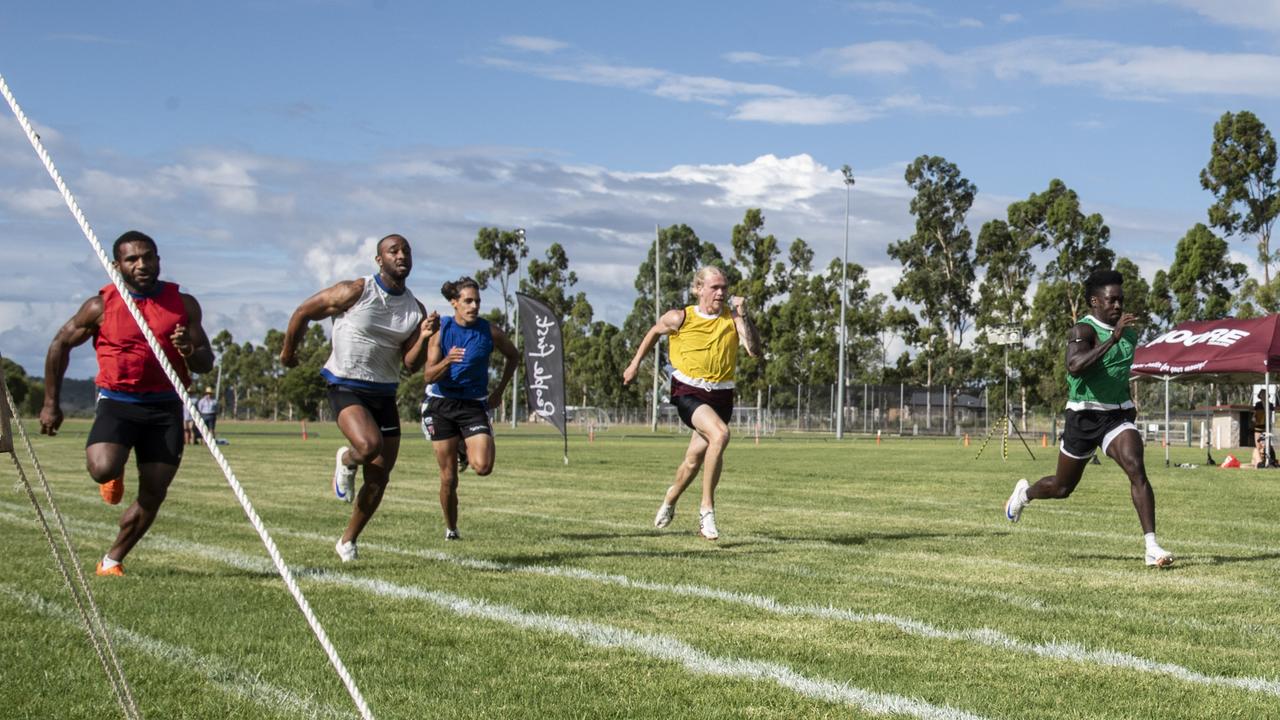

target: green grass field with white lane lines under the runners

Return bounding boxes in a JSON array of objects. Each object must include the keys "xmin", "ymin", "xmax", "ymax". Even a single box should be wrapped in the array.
[{"xmin": 0, "ymin": 421, "xmax": 1280, "ymax": 720}]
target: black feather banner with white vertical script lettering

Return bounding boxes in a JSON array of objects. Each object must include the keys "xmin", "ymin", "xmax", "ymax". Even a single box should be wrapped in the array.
[{"xmin": 516, "ymin": 292, "xmax": 568, "ymax": 453}]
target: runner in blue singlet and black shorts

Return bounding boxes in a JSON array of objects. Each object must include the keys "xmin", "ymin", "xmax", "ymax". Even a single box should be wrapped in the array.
[{"xmin": 422, "ymin": 278, "xmax": 520, "ymax": 539}]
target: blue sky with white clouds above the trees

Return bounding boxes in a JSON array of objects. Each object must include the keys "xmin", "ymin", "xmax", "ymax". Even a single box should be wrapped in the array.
[{"xmin": 0, "ymin": 0, "xmax": 1280, "ymax": 377}]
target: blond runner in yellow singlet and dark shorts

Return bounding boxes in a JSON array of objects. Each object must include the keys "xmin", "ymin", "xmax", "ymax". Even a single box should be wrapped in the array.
[{"xmin": 622, "ymin": 265, "xmax": 760, "ymax": 541}]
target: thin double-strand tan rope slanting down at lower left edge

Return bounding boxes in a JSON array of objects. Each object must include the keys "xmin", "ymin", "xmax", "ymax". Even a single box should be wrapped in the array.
[{"xmin": 0, "ymin": 388, "xmax": 142, "ymax": 720}]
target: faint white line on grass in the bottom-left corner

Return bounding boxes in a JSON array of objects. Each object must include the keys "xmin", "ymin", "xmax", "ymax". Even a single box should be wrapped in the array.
[{"xmin": 0, "ymin": 584, "xmax": 351, "ymax": 717}]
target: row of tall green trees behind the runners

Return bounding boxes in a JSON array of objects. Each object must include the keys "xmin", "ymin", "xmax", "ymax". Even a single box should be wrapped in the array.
[{"xmin": 10, "ymin": 111, "xmax": 1280, "ymax": 419}]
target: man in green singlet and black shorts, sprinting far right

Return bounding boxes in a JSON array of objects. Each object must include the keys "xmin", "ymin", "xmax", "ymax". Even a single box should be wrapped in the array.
[{"xmin": 1005, "ymin": 270, "xmax": 1174, "ymax": 568}]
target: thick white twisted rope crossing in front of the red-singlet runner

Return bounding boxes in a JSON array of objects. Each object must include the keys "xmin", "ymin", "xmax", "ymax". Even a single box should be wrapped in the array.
[{"xmin": 0, "ymin": 74, "xmax": 374, "ymax": 720}]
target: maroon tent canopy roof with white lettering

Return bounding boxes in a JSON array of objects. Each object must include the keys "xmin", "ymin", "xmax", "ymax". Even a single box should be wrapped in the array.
[{"xmin": 1133, "ymin": 315, "xmax": 1280, "ymax": 377}]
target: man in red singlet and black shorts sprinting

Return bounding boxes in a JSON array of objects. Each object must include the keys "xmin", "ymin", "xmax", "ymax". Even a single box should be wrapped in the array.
[{"xmin": 40, "ymin": 231, "xmax": 214, "ymax": 575}]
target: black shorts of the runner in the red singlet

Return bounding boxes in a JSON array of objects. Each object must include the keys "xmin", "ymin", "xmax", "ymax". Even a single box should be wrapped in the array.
[{"xmin": 84, "ymin": 397, "xmax": 183, "ymax": 466}]
